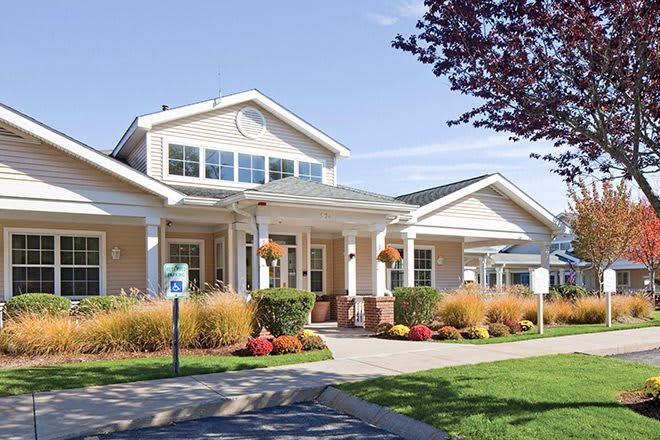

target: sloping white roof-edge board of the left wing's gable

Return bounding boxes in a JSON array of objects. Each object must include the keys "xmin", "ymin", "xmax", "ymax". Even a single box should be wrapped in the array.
[{"xmin": 0, "ymin": 103, "xmax": 183, "ymax": 204}]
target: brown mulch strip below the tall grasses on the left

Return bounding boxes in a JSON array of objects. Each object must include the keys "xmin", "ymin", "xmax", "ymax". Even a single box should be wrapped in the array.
[{"xmin": 0, "ymin": 343, "xmax": 245, "ymax": 369}]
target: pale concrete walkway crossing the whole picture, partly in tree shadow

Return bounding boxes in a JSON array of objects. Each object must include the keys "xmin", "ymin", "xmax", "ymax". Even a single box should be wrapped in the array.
[{"xmin": 0, "ymin": 327, "xmax": 660, "ymax": 440}]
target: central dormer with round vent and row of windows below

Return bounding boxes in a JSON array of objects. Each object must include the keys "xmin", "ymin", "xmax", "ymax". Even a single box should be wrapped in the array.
[{"xmin": 112, "ymin": 90, "xmax": 350, "ymax": 190}]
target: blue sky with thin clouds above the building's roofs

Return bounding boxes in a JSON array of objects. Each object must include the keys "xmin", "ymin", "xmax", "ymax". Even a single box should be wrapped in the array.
[{"xmin": 0, "ymin": 0, "xmax": 566, "ymax": 213}]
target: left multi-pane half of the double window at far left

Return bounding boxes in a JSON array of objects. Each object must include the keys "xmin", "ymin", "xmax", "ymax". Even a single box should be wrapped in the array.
[{"xmin": 11, "ymin": 234, "xmax": 55, "ymax": 295}]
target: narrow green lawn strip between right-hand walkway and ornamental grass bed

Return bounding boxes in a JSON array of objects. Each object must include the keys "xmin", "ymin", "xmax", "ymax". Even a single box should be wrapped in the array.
[{"xmin": 442, "ymin": 311, "xmax": 660, "ymax": 345}]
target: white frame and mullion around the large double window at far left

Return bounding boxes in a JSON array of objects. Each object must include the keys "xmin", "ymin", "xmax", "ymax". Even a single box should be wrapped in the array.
[{"xmin": 3, "ymin": 227, "xmax": 108, "ymax": 300}]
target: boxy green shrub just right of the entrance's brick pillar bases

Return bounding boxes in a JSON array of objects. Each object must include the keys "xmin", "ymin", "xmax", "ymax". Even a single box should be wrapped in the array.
[{"xmin": 393, "ymin": 286, "xmax": 440, "ymax": 326}]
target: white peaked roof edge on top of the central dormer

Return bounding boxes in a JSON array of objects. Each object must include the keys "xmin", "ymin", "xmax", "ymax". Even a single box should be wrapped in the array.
[{"xmin": 112, "ymin": 89, "xmax": 350, "ymax": 159}]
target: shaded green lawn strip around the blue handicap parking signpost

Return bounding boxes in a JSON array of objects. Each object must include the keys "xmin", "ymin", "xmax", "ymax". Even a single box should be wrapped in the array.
[{"xmin": 0, "ymin": 350, "xmax": 332, "ymax": 397}]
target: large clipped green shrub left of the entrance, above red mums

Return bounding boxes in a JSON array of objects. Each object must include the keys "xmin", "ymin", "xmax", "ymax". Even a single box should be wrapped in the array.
[{"xmin": 252, "ymin": 288, "xmax": 316, "ymax": 337}]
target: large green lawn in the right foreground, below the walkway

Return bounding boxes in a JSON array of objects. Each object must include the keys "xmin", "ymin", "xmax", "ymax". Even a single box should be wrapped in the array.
[{"xmin": 341, "ymin": 354, "xmax": 660, "ymax": 440}]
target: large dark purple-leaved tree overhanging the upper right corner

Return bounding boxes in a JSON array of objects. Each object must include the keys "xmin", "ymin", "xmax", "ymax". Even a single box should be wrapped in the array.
[{"xmin": 392, "ymin": 0, "xmax": 660, "ymax": 216}]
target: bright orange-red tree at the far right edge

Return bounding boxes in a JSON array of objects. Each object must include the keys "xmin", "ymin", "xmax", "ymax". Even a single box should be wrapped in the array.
[{"xmin": 626, "ymin": 201, "xmax": 660, "ymax": 306}]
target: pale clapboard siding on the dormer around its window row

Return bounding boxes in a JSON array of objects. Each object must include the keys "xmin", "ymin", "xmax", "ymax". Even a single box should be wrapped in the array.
[{"xmin": 150, "ymin": 104, "xmax": 335, "ymax": 186}]
